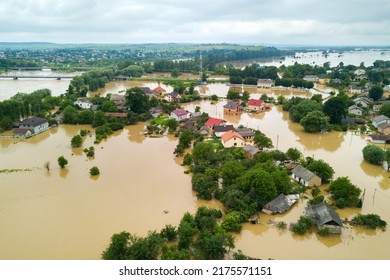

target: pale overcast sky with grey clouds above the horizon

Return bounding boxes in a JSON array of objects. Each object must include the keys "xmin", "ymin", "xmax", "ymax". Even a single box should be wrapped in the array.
[{"xmin": 0, "ymin": 0, "xmax": 390, "ymax": 45}]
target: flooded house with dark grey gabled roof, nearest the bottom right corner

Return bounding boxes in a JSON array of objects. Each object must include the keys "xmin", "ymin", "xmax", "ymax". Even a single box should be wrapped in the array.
[{"xmin": 305, "ymin": 202, "xmax": 343, "ymax": 234}]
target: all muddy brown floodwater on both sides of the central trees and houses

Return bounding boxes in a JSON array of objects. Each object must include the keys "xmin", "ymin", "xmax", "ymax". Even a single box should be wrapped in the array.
[{"xmin": 0, "ymin": 82, "xmax": 390, "ymax": 259}]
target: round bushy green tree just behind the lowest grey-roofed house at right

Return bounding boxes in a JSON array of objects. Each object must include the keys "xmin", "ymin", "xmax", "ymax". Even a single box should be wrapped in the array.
[{"xmin": 328, "ymin": 177, "xmax": 361, "ymax": 208}]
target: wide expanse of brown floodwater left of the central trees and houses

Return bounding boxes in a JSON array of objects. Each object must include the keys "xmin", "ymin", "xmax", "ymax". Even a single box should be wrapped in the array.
[{"xmin": 0, "ymin": 124, "xmax": 216, "ymax": 259}]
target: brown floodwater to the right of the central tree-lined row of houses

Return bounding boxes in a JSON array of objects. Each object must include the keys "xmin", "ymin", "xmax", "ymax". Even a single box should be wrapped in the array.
[{"xmin": 185, "ymin": 101, "xmax": 390, "ymax": 259}]
